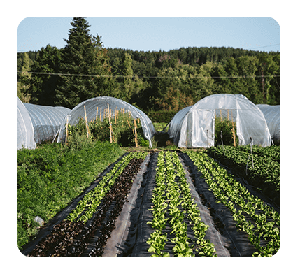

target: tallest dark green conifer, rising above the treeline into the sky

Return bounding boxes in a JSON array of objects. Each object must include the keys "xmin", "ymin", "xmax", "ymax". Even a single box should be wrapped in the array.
[{"xmin": 56, "ymin": 17, "xmax": 114, "ymax": 108}]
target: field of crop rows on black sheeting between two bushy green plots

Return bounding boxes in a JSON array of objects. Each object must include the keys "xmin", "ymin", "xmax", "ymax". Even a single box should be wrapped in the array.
[{"xmin": 18, "ymin": 146, "xmax": 280, "ymax": 257}]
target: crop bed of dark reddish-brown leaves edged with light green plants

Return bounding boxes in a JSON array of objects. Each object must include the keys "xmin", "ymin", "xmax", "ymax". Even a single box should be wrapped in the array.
[{"xmin": 29, "ymin": 153, "xmax": 147, "ymax": 257}]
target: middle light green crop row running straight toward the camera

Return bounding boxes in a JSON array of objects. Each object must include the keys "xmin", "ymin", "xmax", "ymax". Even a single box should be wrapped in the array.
[{"xmin": 147, "ymin": 151, "xmax": 216, "ymax": 257}]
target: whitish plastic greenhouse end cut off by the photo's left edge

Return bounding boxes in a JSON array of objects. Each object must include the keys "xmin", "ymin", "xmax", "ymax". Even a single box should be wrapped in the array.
[{"xmin": 17, "ymin": 96, "xmax": 36, "ymax": 150}]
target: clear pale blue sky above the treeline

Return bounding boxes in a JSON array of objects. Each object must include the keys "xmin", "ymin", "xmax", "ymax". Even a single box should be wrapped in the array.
[{"xmin": 17, "ymin": 17, "xmax": 280, "ymax": 52}]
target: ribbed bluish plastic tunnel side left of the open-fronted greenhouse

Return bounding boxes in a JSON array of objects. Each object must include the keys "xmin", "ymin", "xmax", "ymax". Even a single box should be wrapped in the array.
[{"xmin": 24, "ymin": 103, "xmax": 71, "ymax": 143}]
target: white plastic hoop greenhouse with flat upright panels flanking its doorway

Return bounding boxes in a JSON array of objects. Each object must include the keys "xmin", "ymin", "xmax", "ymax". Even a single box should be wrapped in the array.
[{"xmin": 168, "ymin": 94, "xmax": 271, "ymax": 147}]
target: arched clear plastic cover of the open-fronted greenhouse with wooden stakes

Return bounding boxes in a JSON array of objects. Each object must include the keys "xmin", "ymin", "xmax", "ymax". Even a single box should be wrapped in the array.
[{"xmin": 57, "ymin": 96, "xmax": 156, "ymax": 147}]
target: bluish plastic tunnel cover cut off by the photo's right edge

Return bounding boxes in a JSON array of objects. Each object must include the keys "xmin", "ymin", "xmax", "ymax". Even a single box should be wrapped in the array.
[{"xmin": 257, "ymin": 104, "xmax": 280, "ymax": 143}]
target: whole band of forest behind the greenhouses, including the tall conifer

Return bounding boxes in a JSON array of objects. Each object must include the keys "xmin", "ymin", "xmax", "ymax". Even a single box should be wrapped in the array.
[{"xmin": 17, "ymin": 17, "xmax": 280, "ymax": 113}]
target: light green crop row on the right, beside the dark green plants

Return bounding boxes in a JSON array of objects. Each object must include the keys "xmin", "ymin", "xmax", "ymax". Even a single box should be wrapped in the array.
[{"xmin": 187, "ymin": 151, "xmax": 280, "ymax": 257}]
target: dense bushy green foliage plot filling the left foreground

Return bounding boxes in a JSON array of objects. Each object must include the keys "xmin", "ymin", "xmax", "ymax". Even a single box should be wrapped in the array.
[{"xmin": 17, "ymin": 142, "xmax": 124, "ymax": 248}]
